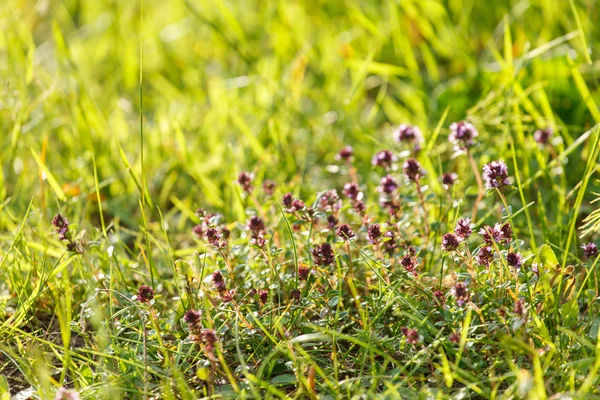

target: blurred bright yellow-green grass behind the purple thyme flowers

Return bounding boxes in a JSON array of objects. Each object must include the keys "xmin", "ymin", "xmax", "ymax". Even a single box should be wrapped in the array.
[{"xmin": 0, "ymin": 0, "xmax": 600, "ymax": 231}]
